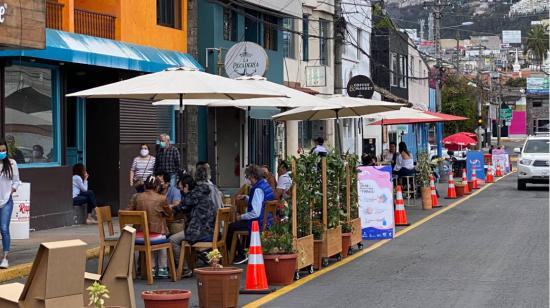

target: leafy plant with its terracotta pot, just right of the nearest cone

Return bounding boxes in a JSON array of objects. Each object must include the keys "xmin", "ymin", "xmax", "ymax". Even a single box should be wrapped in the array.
[{"xmin": 261, "ymin": 223, "xmax": 298, "ymax": 286}]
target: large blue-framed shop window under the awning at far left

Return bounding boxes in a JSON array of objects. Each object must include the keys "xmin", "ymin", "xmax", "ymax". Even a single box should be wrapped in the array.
[{"xmin": 4, "ymin": 65, "xmax": 60, "ymax": 167}]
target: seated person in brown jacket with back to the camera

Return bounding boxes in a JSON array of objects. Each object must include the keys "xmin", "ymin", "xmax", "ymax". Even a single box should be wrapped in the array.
[{"xmin": 128, "ymin": 175, "xmax": 172, "ymax": 278}]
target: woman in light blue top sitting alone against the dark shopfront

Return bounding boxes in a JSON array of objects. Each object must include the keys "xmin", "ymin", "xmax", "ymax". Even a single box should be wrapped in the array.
[{"xmin": 73, "ymin": 164, "xmax": 97, "ymax": 225}]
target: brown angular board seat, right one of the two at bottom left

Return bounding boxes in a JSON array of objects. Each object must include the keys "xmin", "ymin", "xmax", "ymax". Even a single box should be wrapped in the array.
[{"xmin": 84, "ymin": 226, "xmax": 136, "ymax": 308}]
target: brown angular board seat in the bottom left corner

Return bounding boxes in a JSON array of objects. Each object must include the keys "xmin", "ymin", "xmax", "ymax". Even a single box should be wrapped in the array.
[{"xmin": 0, "ymin": 240, "xmax": 88, "ymax": 308}]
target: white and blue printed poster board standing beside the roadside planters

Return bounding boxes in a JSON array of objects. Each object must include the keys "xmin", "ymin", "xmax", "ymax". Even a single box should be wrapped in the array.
[{"xmin": 357, "ymin": 166, "xmax": 395, "ymax": 240}]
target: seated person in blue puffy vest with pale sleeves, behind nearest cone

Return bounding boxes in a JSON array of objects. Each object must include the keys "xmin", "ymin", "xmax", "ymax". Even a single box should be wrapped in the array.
[{"xmin": 226, "ymin": 165, "xmax": 275, "ymax": 264}]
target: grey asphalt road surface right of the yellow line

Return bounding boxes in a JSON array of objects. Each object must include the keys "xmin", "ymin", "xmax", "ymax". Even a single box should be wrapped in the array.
[{"xmin": 266, "ymin": 175, "xmax": 549, "ymax": 308}]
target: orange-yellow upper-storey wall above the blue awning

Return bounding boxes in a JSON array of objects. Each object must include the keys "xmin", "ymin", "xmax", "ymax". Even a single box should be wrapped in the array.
[{"xmin": 59, "ymin": 0, "xmax": 187, "ymax": 52}]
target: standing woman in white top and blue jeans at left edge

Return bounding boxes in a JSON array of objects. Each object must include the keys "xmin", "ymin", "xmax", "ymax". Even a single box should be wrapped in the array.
[{"xmin": 0, "ymin": 140, "xmax": 21, "ymax": 268}]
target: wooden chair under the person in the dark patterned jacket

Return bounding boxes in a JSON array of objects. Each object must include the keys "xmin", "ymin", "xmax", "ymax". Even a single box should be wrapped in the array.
[{"xmin": 177, "ymin": 208, "xmax": 231, "ymax": 279}]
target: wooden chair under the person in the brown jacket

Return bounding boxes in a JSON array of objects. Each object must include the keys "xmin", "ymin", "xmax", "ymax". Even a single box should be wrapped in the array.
[{"xmin": 118, "ymin": 211, "xmax": 176, "ymax": 284}]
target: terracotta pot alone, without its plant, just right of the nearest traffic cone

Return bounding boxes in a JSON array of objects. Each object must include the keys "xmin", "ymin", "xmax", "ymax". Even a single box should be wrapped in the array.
[{"xmin": 264, "ymin": 253, "xmax": 298, "ymax": 286}]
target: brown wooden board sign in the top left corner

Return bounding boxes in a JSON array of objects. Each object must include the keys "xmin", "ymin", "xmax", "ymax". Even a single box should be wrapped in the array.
[{"xmin": 0, "ymin": 0, "xmax": 46, "ymax": 50}]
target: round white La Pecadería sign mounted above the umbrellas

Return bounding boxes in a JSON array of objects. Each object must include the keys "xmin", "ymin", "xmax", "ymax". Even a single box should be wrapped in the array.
[{"xmin": 225, "ymin": 42, "xmax": 269, "ymax": 78}]
